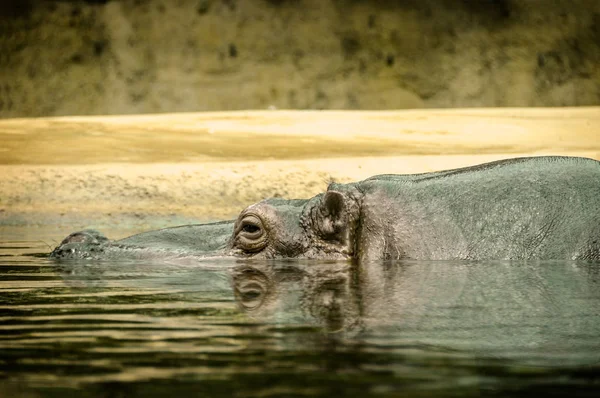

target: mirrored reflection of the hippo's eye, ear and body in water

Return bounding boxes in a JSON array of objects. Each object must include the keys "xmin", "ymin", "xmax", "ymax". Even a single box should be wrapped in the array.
[{"xmin": 230, "ymin": 260, "xmax": 600, "ymax": 365}]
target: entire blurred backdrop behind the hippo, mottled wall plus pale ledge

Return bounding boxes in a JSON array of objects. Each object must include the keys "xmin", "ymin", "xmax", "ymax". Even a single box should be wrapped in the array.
[{"xmin": 0, "ymin": 0, "xmax": 600, "ymax": 235}]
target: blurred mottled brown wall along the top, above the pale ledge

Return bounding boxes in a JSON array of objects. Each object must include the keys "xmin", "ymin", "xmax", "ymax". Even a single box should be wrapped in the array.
[{"xmin": 0, "ymin": 0, "xmax": 600, "ymax": 118}]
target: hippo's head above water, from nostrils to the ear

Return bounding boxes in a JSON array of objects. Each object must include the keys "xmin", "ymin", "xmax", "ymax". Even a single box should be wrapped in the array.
[{"xmin": 50, "ymin": 186, "xmax": 359, "ymax": 259}]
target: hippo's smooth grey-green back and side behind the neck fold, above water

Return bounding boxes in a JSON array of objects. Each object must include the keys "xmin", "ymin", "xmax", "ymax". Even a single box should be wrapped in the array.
[{"xmin": 356, "ymin": 157, "xmax": 600, "ymax": 259}]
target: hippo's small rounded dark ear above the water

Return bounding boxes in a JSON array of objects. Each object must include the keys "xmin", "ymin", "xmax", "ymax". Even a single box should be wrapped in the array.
[{"xmin": 315, "ymin": 191, "xmax": 348, "ymax": 241}]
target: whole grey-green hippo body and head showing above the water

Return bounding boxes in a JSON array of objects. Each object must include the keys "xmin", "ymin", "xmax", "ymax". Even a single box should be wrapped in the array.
[{"xmin": 51, "ymin": 157, "xmax": 600, "ymax": 261}]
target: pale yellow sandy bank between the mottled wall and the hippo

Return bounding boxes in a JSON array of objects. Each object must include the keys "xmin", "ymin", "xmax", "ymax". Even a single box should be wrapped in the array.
[{"xmin": 0, "ymin": 108, "xmax": 600, "ymax": 238}]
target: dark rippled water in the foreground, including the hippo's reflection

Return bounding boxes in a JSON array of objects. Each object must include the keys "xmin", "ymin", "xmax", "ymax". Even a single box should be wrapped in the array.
[{"xmin": 0, "ymin": 234, "xmax": 600, "ymax": 397}]
